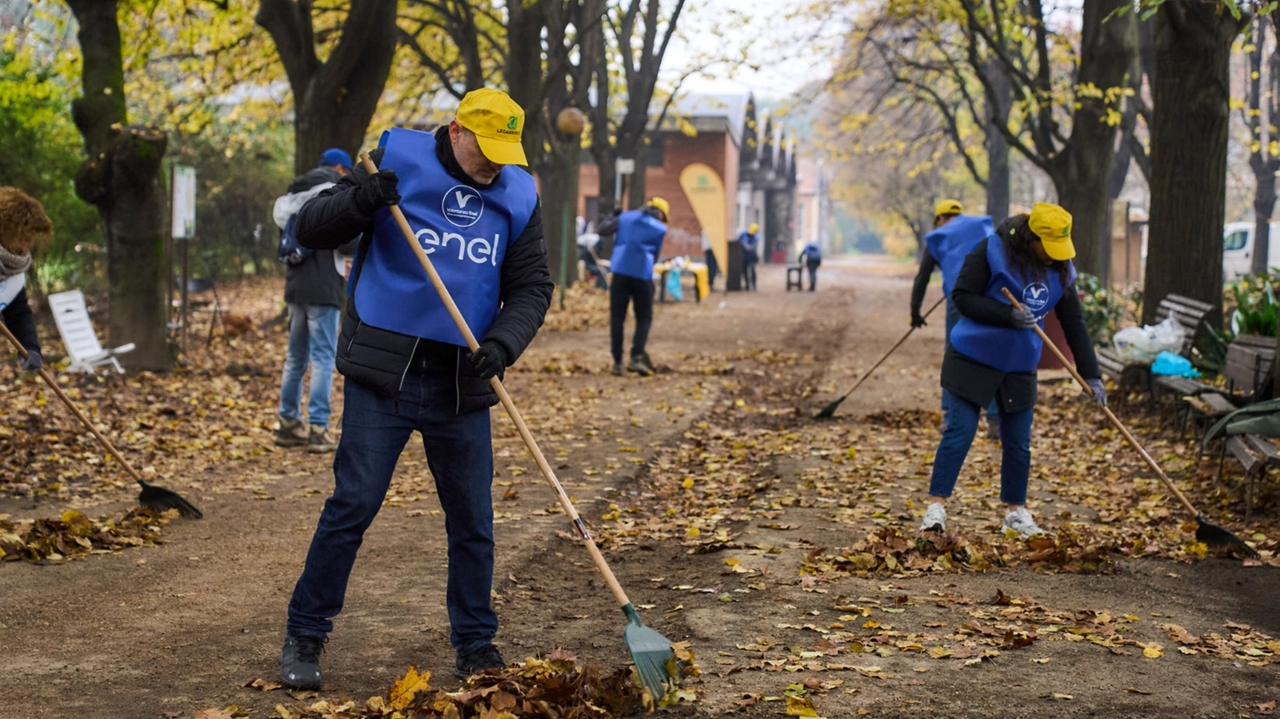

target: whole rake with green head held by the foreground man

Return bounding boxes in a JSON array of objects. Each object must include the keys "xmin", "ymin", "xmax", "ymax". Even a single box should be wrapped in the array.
[{"xmin": 360, "ymin": 152, "xmax": 680, "ymax": 700}]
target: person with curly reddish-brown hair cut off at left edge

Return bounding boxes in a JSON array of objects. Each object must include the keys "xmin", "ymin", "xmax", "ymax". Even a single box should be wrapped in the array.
[{"xmin": 0, "ymin": 187, "xmax": 54, "ymax": 372}]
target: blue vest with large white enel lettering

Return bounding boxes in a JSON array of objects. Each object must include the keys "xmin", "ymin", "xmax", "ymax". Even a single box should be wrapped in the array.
[{"xmin": 353, "ymin": 128, "xmax": 538, "ymax": 347}]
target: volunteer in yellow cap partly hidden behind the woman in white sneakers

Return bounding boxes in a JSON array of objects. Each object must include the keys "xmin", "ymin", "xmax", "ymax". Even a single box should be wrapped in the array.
[{"xmin": 911, "ymin": 200, "xmax": 1000, "ymax": 440}]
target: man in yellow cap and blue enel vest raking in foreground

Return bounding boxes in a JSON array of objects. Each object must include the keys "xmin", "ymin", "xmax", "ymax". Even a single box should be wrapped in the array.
[{"xmin": 279, "ymin": 90, "xmax": 553, "ymax": 688}]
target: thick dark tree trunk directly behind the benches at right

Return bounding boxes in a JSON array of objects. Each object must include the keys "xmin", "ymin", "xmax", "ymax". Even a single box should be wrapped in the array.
[{"xmin": 1143, "ymin": 0, "xmax": 1242, "ymax": 326}]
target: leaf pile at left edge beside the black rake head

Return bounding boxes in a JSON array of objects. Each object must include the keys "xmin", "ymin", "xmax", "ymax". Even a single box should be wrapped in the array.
[{"xmin": 0, "ymin": 507, "xmax": 178, "ymax": 562}]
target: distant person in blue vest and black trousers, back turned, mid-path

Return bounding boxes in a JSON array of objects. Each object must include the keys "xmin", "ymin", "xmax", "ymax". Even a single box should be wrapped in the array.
[{"xmin": 599, "ymin": 197, "xmax": 671, "ymax": 377}]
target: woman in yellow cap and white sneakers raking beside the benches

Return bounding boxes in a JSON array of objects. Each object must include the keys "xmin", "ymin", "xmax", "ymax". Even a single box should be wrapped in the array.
[{"xmin": 920, "ymin": 202, "xmax": 1107, "ymax": 536}]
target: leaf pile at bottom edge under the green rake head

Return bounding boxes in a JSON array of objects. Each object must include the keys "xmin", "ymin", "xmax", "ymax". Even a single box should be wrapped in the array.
[{"xmin": 222, "ymin": 644, "xmax": 699, "ymax": 719}]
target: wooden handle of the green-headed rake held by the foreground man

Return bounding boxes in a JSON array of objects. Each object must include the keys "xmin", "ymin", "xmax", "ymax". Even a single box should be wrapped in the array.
[{"xmin": 360, "ymin": 152, "xmax": 631, "ymax": 606}]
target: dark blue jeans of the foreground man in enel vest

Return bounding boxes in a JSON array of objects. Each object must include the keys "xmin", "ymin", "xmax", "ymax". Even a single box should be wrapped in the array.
[{"xmin": 288, "ymin": 374, "xmax": 498, "ymax": 652}]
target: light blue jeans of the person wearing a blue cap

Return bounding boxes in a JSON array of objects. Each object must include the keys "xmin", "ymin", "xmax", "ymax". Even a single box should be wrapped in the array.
[{"xmin": 280, "ymin": 303, "xmax": 339, "ymax": 429}]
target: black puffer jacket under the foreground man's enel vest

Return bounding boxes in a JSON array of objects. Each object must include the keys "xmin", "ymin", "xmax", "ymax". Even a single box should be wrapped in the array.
[{"xmin": 297, "ymin": 128, "xmax": 554, "ymax": 413}]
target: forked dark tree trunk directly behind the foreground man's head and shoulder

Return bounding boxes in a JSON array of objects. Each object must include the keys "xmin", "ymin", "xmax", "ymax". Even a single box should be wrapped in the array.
[{"xmin": 256, "ymin": 0, "xmax": 397, "ymax": 174}]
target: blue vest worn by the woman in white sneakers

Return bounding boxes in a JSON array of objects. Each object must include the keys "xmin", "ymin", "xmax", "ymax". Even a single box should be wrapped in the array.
[{"xmin": 951, "ymin": 234, "xmax": 1075, "ymax": 372}]
